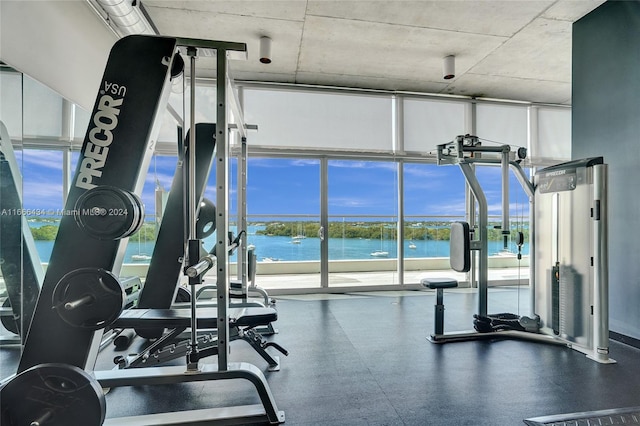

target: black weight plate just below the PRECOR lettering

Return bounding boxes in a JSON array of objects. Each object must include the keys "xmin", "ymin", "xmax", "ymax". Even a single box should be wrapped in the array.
[{"xmin": 74, "ymin": 186, "xmax": 144, "ymax": 240}]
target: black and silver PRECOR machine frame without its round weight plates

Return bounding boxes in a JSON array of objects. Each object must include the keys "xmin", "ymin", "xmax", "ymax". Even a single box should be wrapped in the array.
[{"xmin": 0, "ymin": 36, "xmax": 285, "ymax": 425}]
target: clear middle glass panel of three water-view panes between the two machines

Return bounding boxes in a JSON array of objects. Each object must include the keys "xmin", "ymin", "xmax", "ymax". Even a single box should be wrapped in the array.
[{"xmin": 328, "ymin": 160, "xmax": 399, "ymax": 287}]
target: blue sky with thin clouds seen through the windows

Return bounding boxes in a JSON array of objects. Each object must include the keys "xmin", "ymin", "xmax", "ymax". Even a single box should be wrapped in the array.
[{"xmin": 16, "ymin": 150, "xmax": 528, "ymax": 223}]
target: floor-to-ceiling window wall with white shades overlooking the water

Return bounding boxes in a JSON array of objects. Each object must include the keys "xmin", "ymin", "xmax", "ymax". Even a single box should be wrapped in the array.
[{"xmin": 0, "ymin": 68, "xmax": 570, "ymax": 298}]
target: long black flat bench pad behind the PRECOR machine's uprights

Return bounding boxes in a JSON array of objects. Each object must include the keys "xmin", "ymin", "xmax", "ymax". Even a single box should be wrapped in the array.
[{"xmin": 112, "ymin": 307, "xmax": 278, "ymax": 329}]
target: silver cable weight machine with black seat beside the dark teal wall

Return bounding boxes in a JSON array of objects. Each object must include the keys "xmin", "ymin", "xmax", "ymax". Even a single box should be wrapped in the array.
[{"xmin": 423, "ymin": 135, "xmax": 615, "ymax": 363}]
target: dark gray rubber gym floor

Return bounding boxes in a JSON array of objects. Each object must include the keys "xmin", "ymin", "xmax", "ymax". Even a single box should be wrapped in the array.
[{"xmin": 0, "ymin": 288, "xmax": 640, "ymax": 426}]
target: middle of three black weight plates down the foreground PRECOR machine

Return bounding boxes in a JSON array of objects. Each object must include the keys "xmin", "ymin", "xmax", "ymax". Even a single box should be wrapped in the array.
[{"xmin": 52, "ymin": 268, "xmax": 126, "ymax": 330}]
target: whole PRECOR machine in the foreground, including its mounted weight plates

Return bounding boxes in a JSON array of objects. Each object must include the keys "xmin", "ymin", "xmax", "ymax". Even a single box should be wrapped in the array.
[{"xmin": 0, "ymin": 36, "xmax": 284, "ymax": 426}]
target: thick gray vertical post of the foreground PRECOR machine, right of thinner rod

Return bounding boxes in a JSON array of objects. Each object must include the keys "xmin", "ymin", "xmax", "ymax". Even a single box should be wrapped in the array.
[{"xmin": 216, "ymin": 47, "xmax": 229, "ymax": 371}]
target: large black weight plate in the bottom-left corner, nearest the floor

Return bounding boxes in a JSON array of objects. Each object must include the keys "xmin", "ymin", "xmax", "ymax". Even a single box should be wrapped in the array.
[{"xmin": 0, "ymin": 364, "xmax": 106, "ymax": 426}]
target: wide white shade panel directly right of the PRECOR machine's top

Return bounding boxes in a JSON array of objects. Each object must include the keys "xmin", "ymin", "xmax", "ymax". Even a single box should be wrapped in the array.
[{"xmin": 243, "ymin": 89, "xmax": 392, "ymax": 151}]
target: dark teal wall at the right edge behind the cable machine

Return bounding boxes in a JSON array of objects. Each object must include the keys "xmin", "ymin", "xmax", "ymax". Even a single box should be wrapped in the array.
[{"xmin": 572, "ymin": 1, "xmax": 640, "ymax": 339}]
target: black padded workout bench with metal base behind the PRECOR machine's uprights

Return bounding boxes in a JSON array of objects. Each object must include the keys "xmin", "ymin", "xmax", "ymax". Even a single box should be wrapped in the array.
[{"xmin": 113, "ymin": 307, "xmax": 288, "ymax": 371}]
